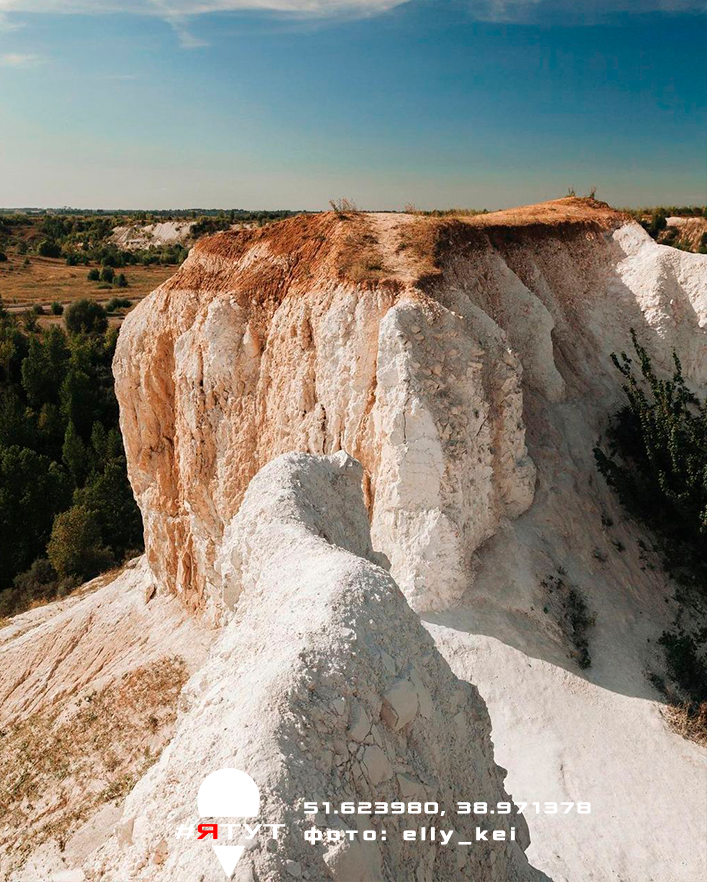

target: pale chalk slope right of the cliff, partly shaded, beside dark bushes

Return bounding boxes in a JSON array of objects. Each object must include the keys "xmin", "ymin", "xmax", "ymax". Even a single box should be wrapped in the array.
[{"xmin": 424, "ymin": 225, "xmax": 707, "ymax": 882}]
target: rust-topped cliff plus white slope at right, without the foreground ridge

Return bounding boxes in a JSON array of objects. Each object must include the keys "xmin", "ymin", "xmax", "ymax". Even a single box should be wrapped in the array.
[{"xmin": 110, "ymin": 199, "xmax": 707, "ymax": 882}]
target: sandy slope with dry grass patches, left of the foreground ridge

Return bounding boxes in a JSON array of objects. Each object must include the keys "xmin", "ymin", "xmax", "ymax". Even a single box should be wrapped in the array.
[{"xmin": 0, "ymin": 557, "xmax": 213, "ymax": 882}]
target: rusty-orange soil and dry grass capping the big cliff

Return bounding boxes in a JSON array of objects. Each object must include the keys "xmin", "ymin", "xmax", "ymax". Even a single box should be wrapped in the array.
[{"xmin": 174, "ymin": 197, "xmax": 625, "ymax": 302}]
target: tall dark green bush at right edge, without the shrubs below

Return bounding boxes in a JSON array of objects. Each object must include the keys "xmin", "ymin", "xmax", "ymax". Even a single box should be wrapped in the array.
[{"xmin": 594, "ymin": 329, "xmax": 707, "ymax": 591}]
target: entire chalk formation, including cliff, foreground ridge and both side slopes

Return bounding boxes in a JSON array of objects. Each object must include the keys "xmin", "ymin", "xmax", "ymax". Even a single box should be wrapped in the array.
[{"xmin": 0, "ymin": 198, "xmax": 707, "ymax": 882}]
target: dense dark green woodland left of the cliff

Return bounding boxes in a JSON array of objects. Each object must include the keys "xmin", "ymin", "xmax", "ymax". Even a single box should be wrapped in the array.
[{"xmin": 0, "ymin": 300, "xmax": 143, "ymax": 616}]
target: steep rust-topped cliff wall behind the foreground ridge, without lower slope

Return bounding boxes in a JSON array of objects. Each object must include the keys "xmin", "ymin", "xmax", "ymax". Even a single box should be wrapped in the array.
[{"xmin": 115, "ymin": 199, "xmax": 707, "ymax": 617}]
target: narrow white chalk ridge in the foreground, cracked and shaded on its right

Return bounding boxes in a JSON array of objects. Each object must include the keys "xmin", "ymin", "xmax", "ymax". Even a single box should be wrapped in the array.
[{"xmin": 90, "ymin": 452, "xmax": 546, "ymax": 882}]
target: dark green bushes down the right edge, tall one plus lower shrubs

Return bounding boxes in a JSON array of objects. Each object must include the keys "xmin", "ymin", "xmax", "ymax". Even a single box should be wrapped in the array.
[{"xmin": 594, "ymin": 329, "xmax": 707, "ymax": 743}]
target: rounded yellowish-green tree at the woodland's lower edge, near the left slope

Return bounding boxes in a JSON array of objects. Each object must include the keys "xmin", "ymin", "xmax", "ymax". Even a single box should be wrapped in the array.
[{"xmin": 47, "ymin": 505, "xmax": 111, "ymax": 580}]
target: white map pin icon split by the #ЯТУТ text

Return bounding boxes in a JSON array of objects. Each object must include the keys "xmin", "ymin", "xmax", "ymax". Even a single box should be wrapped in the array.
[{"xmin": 197, "ymin": 769, "xmax": 260, "ymax": 879}]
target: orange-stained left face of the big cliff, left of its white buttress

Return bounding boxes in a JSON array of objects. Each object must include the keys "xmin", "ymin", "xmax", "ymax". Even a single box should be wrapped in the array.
[{"xmin": 115, "ymin": 217, "xmax": 394, "ymax": 610}]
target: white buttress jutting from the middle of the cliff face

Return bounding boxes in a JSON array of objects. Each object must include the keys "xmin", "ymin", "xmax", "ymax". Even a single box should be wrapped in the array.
[{"xmin": 372, "ymin": 300, "xmax": 535, "ymax": 609}]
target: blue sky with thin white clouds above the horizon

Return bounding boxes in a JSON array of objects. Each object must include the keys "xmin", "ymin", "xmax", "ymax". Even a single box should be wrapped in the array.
[{"xmin": 0, "ymin": 0, "xmax": 707, "ymax": 209}]
